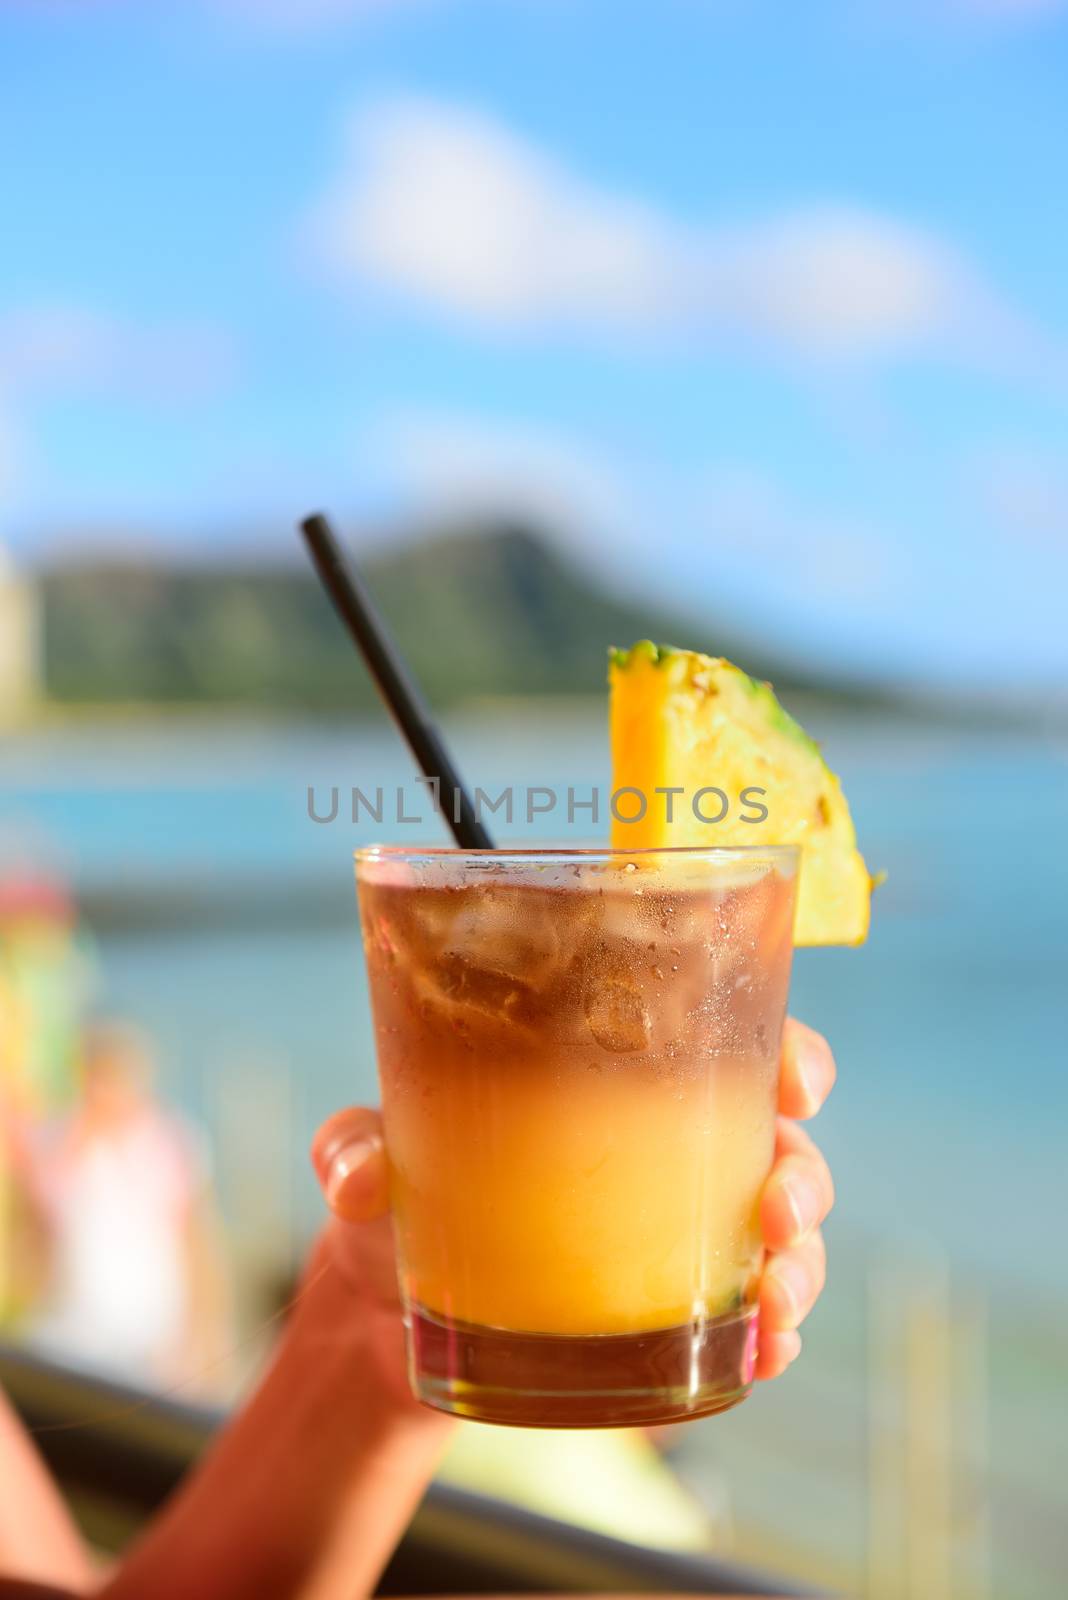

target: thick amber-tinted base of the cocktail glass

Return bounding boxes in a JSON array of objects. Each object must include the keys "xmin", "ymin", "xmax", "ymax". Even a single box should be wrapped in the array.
[{"xmin": 408, "ymin": 1306, "xmax": 756, "ymax": 1427}]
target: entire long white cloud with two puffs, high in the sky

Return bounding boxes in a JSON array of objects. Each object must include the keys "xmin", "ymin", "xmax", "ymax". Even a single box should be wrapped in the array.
[{"xmin": 312, "ymin": 99, "xmax": 1036, "ymax": 362}]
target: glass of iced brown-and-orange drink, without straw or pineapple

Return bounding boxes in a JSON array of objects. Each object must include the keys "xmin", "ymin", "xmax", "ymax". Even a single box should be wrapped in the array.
[{"xmin": 357, "ymin": 848, "xmax": 796, "ymax": 1427}]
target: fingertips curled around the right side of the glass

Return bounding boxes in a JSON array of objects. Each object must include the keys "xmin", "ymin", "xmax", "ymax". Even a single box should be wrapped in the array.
[{"xmin": 756, "ymin": 1018, "xmax": 836, "ymax": 1378}]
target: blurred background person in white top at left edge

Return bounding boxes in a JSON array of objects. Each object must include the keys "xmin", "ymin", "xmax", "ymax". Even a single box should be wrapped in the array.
[{"xmin": 21, "ymin": 1022, "xmax": 232, "ymax": 1392}]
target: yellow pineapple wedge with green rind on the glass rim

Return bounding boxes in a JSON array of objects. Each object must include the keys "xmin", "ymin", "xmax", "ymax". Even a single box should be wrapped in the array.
[{"xmin": 609, "ymin": 640, "xmax": 873, "ymax": 944}]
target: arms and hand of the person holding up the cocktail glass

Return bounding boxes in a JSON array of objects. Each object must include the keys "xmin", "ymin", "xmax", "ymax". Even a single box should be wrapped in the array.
[{"xmin": 0, "ymin": 1022, "xmax": 835, "ymax": 1600}]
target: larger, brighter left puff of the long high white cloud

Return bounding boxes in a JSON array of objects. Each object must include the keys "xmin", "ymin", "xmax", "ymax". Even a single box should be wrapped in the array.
[{"xmin": 317, "ymin": 101, "xmax": 676, "ymax": 325}]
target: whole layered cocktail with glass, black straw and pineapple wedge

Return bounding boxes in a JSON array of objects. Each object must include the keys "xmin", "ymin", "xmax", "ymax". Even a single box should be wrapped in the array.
[{"xmin": 301, "ymin": 514, "xmax": 871, "ymax": 1427}]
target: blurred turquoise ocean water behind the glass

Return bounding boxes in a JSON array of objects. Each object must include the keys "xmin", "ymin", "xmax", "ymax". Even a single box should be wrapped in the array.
[{"xmin": 0, "ymin": 704, "xmax": 1068, "ymax": 1600}]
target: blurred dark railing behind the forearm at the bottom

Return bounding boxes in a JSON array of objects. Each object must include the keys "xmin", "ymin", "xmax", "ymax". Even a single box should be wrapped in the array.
[{"xmin": 0, "ymin": 1346, "xmax": 814, "ymax": 1597}]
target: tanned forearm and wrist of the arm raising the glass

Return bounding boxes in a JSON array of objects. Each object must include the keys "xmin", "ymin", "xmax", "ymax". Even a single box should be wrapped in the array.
[{"xmin": 106, "ymin": 1270, "xmax": 448, "ymax": 1600}]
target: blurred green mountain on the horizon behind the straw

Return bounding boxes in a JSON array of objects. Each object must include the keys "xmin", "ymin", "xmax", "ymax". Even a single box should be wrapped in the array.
[{"xmin": 42, "ymin": 526, "xmax": 876, "ymax": 710}]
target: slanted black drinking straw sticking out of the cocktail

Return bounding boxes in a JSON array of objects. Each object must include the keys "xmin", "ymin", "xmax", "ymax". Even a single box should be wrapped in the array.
[{"xmin": 301, "ymin": 512, "xmax": 492, "ymax": 850}]
